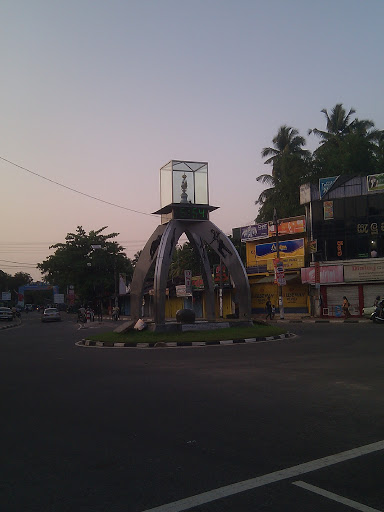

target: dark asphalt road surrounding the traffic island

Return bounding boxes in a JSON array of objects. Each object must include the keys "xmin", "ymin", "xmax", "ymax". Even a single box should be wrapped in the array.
[{"xmin": 0, "ymin": 314, "xmax": 384, "ymax": 512}]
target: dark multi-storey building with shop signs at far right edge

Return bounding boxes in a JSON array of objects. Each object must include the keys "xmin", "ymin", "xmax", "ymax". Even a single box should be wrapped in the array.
[{"xmin": 300, "ymin": 174, "xmax": 384, "ymax": 317}]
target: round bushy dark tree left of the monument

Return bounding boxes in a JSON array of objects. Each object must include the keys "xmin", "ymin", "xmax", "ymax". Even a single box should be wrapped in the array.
[{"xmin": 37, "ymin": 226, "xmax": 133, "ymax": 302}]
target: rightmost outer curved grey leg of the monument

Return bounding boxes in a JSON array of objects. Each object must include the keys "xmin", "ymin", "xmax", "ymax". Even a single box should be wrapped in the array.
[{"xmin": 193, "ymin": 221, "xmax": 251, "ymax": 320}]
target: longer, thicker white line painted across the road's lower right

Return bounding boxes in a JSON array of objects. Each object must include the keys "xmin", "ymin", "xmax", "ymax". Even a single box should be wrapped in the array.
[{"xmin": 143, "ymin": 441, "xmax": 384, "ymax": 512}]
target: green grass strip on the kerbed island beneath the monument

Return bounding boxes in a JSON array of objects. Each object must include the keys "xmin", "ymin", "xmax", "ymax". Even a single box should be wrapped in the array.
[{"xmin": 87, "ymin": 324, "xmax": 287, "ymax": 344}]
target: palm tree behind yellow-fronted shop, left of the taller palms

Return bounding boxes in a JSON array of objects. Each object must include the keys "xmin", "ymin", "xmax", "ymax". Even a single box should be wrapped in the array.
[{"xmin": 255, "ymin": 125, "xmax": 311, "ymax": 221}]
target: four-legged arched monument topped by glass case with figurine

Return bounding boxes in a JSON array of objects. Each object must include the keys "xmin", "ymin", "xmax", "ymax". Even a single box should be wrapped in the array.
[{"xmin": 131, "ymin": 160, "xmax": 251, "ymax": 325}]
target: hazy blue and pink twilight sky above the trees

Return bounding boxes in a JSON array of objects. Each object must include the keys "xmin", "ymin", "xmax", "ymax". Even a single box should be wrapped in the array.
[{"xmin": 0, "ymin": 0, "xmax": 384, "ymax": 280}]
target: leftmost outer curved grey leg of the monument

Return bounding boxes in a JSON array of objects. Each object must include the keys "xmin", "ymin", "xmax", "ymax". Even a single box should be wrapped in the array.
[{"xmin": 131, "ymin": 224, "xmax": 166, "ymax": 320}]
